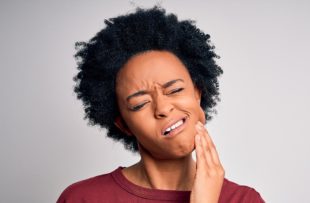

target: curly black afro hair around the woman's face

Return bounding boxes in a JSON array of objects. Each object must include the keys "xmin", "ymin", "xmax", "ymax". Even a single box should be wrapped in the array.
[{"xmin": 74, "ymin": 7, "xmax": 223, "ymax": 152}]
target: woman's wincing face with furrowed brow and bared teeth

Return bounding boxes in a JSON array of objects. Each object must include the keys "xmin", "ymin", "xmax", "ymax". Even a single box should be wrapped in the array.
[{"xmin": 116, "ymin": 51, "xmax": 205, "ymax": 159}]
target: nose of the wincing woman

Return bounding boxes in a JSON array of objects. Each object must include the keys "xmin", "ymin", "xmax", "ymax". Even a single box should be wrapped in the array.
[{"xmin": 154, "ymin": 95, "xmax": 174, "ymax": 118}]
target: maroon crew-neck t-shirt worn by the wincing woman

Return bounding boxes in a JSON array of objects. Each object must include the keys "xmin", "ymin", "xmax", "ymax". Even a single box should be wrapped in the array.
[{"xmin": 57, "ymin": 167, "xmax": 264, "ymax": 203}]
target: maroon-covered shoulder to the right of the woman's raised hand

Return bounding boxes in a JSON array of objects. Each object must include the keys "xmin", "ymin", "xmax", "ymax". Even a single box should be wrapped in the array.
[{"xmin": 220, "ymin": 179, "xmax": 265, "ymax": 203}]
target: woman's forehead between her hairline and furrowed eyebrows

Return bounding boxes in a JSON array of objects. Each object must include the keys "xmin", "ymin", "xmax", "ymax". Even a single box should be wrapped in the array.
[{"xmin": 116, "ymin": 51, "xmax": 191, "ymax": 91}]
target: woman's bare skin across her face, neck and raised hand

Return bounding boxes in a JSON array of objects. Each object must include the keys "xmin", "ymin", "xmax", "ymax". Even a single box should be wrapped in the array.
[{"xmin": 115, "ymin": 51, "xmax": 224, "ymax": 203}]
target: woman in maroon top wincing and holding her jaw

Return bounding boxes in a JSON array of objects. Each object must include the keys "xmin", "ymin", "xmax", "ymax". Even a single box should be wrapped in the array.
[{"xmin": 57, "ymin": 7, "xmax": 264, "ymax": 203}]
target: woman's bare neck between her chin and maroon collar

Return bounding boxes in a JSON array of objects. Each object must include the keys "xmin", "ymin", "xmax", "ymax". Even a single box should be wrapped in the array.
[{"xmin": 123, "ymin": 146, "xmax": 196, "ymax": 191}]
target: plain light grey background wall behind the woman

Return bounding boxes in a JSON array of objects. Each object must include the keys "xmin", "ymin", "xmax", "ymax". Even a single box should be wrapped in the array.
[{"xmin": 0, "ymin": 0, "xmax": 310, "ymax": 203}]
